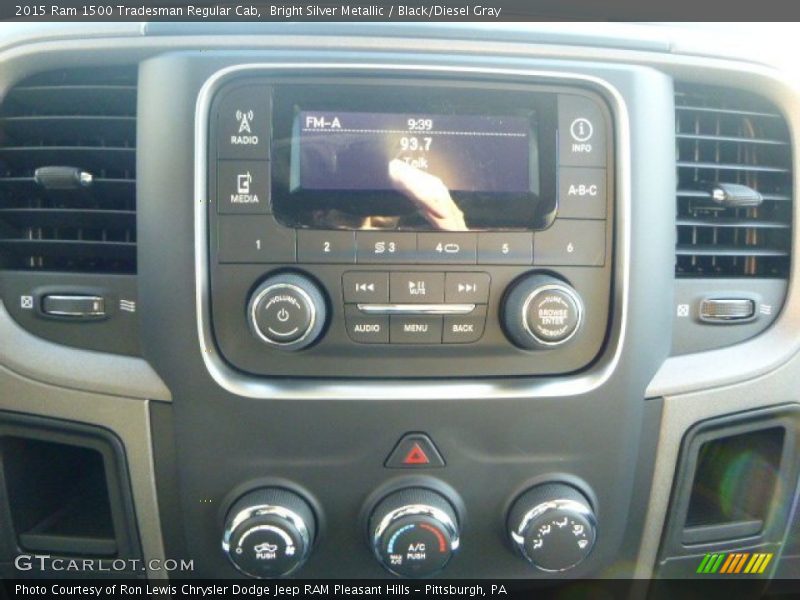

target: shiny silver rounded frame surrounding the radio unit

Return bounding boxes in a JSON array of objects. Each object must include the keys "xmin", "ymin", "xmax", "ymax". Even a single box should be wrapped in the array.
[{"xmin": 194, "ymin": 62, "xmax": 631, "ymax": 400}]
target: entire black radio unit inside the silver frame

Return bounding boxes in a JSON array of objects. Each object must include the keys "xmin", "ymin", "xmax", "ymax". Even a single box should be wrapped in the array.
[{"xmin": 205, "ymin": 70, "xmax": 614, "ymax": 377}]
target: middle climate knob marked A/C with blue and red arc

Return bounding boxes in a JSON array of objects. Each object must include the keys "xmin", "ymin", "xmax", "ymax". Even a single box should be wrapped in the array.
[{"xmin": 369, "ymin": 488, "xmax": 459, "ymax": 577}]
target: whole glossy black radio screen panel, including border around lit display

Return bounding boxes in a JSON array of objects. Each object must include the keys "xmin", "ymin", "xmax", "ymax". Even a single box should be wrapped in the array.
[{"xmin": 272, "ymin": 83, "xmax": 556, "ymax": 231}]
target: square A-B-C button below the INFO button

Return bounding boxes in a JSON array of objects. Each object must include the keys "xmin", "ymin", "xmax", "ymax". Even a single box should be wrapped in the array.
[{"xmin": 558, "ymin": 167, "xmax": 606, "ymax": 219}]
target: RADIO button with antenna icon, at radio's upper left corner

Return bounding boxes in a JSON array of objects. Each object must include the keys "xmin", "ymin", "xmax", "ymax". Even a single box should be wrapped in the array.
[{"xmin": 217, "ymin": 85, "xmax": 270, "ymax": 160}]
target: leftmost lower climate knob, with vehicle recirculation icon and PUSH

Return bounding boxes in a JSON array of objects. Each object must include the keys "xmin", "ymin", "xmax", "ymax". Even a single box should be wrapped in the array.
[{"xmin": 222, "ymin": 488, "xmax": 316, "ymax": 578}]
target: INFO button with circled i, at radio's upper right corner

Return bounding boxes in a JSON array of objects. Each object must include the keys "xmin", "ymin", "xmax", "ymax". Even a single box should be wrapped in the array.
[{"xmin": 558, "ymin": 94, "xmax": 606, "ymax": 167}]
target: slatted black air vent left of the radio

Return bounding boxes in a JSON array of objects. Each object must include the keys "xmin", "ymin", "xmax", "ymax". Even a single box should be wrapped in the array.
[{"xmin": 0, "ymin": 67, "xmax": 136, "ymax": 273}]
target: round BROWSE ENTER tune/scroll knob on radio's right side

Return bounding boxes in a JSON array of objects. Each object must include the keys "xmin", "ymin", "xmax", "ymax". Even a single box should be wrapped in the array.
[{"xmin": 502, "ymin": 273, "xmax": 583, "ymax": 350}]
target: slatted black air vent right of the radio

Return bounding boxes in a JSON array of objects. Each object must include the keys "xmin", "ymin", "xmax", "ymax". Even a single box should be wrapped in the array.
[{"xmin": 675, "ymin": 85, "xmax": 792, "ymax": 278}]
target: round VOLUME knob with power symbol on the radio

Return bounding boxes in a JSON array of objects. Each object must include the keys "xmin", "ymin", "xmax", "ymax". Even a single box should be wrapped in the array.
[{"xmin": 247, "ymin": 273, "xmax": 326, "ymax": 351}]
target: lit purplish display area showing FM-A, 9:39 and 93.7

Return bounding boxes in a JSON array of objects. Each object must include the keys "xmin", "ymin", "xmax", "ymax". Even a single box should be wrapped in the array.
[{"xmin": 291, "ymin": 110, "xmax": 539, "ymax": 199}]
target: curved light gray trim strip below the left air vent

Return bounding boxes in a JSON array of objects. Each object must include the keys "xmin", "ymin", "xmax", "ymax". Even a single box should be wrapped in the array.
[{"xmin": 0, "ymin": 301, "xmax": 172, "ymax": 410}]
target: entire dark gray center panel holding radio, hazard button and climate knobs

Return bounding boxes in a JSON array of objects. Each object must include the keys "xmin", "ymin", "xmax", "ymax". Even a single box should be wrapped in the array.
[{"xmin": 137, "ymin": 51, "xmax": 675, "ymax": 578}]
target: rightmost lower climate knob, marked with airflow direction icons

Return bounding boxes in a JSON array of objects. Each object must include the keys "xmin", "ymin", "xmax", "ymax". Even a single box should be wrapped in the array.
[{"xmin": 508, "ymin": 483, "xmax": 597, "ymax": 573}]
